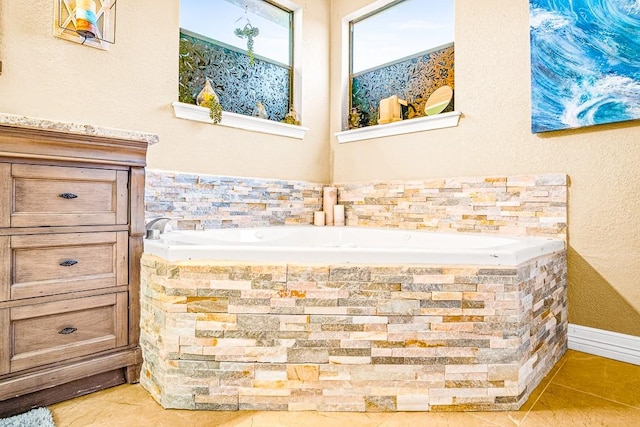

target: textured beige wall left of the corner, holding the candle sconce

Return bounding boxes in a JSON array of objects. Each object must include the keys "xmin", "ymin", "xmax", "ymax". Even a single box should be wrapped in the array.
[{"xmin": 0, "ymin": 0, "xmax": 329, "ymax": 182}]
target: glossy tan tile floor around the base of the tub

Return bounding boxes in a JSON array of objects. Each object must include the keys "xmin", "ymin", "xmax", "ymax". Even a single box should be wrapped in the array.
[{"xmin": 50, "ymin": 350, "xmax": 640, "ymax": 427}]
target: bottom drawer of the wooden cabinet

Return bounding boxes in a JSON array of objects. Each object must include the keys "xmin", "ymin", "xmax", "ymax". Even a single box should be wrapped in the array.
[{"xmin": 9, "ymin": 292, "xmax": 128, "ymax": 372}]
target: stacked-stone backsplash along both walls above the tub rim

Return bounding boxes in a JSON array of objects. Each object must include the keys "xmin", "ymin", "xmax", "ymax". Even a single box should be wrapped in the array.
[{"xmin": 145, "ymin": 170, "xmax": 567, "ymax": 239}]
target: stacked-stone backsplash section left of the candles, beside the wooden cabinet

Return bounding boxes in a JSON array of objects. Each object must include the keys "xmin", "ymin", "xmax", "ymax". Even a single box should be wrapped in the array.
[{"xmin": 145, "ymin": 169, "xmax": 324, "ymax": 229}]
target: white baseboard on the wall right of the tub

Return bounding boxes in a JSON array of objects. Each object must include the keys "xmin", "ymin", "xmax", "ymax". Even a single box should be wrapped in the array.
[{"xmin": 568, "ymin": 323, "xmax": 640, "ymax": 365}]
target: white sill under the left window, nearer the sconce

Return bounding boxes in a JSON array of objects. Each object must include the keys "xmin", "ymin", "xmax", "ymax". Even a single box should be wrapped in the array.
[{"xmin": 171, "ymin": 102, "xmax": 309, "ymax": 139}]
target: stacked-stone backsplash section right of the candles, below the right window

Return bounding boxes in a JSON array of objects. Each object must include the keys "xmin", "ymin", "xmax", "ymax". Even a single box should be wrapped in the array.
[{"xmin": 333, "ymin": 174, "xmax": 567, "ymax": 239}]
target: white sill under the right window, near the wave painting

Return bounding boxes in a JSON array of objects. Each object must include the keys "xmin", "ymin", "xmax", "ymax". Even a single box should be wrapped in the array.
[{"xmin": 335, "ymin": 111, "xmax": 462, "ymax": 144}]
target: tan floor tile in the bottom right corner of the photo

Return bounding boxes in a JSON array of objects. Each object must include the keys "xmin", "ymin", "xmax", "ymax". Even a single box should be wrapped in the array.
[{"xmin": 520, "ymin": 384, "xmax": 640, "ymax": 427}]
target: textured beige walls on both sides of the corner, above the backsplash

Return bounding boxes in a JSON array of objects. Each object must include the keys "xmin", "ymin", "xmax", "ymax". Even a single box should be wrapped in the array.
[{"xmin": 0, "ymin": 0, "xmax": 640, "ymax": 335}]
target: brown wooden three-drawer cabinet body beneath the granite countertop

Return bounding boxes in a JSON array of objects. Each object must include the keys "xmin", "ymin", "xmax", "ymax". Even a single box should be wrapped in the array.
[{"xmin": 0, "ymin": 125, "xmax": 147, "ymax": 416}]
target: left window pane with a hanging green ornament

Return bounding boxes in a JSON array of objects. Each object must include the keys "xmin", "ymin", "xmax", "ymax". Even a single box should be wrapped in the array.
[{"xmin": 179, "ymin": 0, "xmax": 294, "ymax": 121}]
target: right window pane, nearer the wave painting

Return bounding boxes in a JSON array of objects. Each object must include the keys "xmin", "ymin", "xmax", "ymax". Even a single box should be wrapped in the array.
[{"xmin": 343, "ymin": 0, "xmax": 454, "ymax": 129}]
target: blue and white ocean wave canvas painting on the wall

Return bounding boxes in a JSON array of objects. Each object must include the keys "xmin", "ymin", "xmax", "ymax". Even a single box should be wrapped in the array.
[{"xmin": 529, "ymin": 0, "xmax": 640, "ymax": 133}]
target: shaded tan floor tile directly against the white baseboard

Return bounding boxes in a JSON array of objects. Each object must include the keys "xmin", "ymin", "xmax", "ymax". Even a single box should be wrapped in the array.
[{"xmin": 554, "ymin": 351, "xmax": 640, "ymax": 410}]
